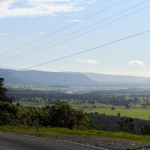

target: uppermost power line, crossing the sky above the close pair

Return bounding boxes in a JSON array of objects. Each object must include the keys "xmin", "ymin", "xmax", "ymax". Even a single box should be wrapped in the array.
[{"xmin": 0, "ymin": 0, "xmax": 126, "ymax": 57}]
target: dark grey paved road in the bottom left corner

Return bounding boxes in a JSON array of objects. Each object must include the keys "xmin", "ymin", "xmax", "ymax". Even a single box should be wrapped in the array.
[{"xmin": 0, "ymin": 132, "xmax": 107, "ymax": 150}]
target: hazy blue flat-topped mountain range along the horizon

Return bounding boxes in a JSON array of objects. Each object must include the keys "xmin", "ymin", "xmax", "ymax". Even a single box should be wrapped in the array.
[{"xmin": 0, "ymin": 69, "xmax": 150, "ymax": 88}]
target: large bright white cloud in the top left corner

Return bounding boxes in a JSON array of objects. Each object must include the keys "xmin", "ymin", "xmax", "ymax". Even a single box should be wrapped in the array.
[{"xmin": 0, "ymin": 0, "xmax": 93, "ymax": 18}]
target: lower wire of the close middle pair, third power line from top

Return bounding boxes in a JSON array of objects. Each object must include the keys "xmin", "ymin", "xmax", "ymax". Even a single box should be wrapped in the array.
[{"xmin": 1, "ymin": 2, "xmax": 150, "ymax": 65}]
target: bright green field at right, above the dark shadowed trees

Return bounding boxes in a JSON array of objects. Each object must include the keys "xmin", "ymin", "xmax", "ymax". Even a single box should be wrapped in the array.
[{"xmin": 70, "ymin": 103, "xmax": 150, "ymax": 120}]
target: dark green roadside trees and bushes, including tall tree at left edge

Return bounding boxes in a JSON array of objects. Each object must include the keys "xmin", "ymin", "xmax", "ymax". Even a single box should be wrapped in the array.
[{"xmin": 0, "ymin": 78, "xmax": 92, "ymax": 129}]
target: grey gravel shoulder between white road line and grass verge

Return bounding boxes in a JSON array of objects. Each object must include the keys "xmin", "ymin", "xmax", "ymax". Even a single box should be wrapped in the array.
[{"xmin": 39, "ymin": 135, "xmax": 150, "ymax": 150}]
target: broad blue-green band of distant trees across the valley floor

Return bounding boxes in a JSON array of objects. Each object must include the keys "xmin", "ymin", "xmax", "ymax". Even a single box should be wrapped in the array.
[{"xmin": 8, "ymin": 89, "xmax": 150, "ymax": 108}]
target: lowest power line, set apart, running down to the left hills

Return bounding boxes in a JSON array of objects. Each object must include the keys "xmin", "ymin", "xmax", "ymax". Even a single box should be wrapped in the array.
[{"xmin": 0, "ymin": 29, "xmax": 150, "ymax": 76}]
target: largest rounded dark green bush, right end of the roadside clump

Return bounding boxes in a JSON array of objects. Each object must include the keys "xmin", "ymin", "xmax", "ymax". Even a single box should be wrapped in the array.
[{"xmin": 40, "ymin": 101, "xmax": 91, "ymax": 129}]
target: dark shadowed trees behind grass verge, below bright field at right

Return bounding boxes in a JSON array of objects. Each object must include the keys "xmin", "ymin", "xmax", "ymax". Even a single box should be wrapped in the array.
[{"xmin": 88, "ymin": 112, "xmax": 150, "ymax": 135}]
